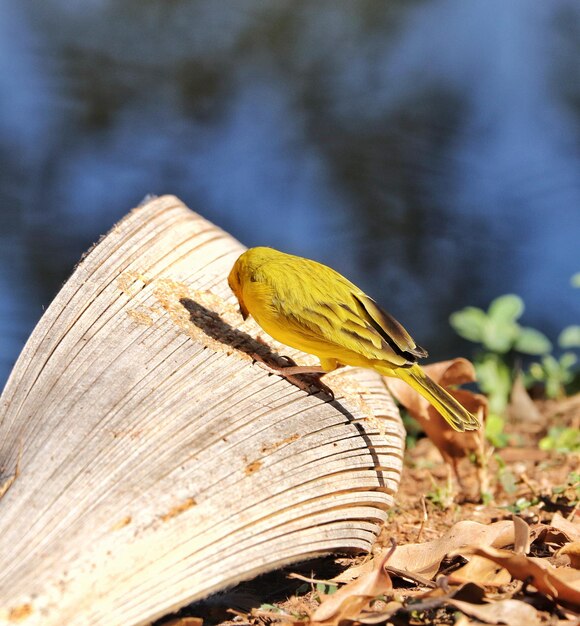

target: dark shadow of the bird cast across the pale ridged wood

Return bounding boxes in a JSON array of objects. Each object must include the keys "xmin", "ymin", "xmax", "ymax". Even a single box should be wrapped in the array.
[{"xmin": 179, "ymin": 298, "xmax": 385, "ymax": 487}]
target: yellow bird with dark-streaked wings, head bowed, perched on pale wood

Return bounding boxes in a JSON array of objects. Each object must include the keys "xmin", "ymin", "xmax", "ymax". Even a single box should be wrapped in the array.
[{"xmin": 228, "ymin": 247, "xmax": 480, "ymax": 431}]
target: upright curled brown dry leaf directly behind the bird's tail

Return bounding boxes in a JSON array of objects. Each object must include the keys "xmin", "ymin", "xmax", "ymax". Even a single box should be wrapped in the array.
[{"xmin": 385, "ymin": 358, "xmax": 487, "ymax": 490}]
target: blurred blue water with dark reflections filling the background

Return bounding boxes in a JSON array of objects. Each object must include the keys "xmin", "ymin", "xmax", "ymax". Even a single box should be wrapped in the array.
[{"xmin": 0, "ymin": 0, "xmax": 580, "ymax": 386}]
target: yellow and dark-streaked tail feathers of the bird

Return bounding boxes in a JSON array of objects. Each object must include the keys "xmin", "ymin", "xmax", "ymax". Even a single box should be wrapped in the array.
[{"xmin": 393, "ymin": 365, "xmax": 481, "ymax": 431}]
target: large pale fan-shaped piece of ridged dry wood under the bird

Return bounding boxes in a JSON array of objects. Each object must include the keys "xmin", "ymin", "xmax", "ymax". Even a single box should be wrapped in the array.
[{"xmin": 0, "ymin": 196, "xmax": 404, "ymax": 626}]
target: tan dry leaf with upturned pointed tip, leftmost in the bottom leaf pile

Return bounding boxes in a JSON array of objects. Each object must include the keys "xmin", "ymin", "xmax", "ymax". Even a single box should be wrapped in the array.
[{"xmin": 311, "ymin": 545, "xmax": 395, "ymax": 626}]
